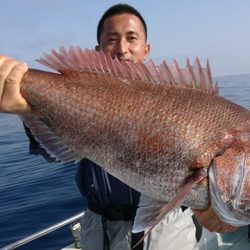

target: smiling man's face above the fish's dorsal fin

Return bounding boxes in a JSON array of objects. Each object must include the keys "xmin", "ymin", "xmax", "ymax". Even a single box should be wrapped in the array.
[{"xmin": 97, "ymin": 14, "xmax": 150, "ymax": 63}]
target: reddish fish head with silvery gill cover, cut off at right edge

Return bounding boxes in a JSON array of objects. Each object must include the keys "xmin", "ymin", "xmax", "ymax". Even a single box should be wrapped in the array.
[{"xmin": 209, "ymin": 136, "xmax": 250, "ymax": 226}]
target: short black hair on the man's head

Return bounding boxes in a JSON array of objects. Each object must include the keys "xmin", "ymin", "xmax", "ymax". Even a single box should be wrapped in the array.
[{"xmin": 97, "ymin": 3, "xmax": 147, "ymax": 45}]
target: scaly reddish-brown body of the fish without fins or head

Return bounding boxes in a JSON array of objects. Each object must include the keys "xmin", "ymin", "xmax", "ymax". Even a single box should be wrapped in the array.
[{"xmin": 21, "ymin": 68, "xmax": 250, "ymax": 215}]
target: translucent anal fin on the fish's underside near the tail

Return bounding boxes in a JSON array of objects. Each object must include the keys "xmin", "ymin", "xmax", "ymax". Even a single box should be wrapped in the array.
[{"xmin": 19, "ymin": 115, "xmax": 80, "ymax": 164}]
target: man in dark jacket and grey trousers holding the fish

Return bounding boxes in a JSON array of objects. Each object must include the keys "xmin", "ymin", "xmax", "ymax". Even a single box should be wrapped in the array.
[{"xmin": 0, "ymin": 4, "xmax": 234, "ymax": 250}]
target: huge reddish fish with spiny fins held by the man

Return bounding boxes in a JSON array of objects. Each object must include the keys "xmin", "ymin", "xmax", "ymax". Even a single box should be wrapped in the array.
[{"xmin": 9, "ymin": 47, "xmax": 250, "ymax": 231}]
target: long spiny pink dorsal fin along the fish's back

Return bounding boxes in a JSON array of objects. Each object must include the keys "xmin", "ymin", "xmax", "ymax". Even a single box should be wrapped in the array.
[{"xmin": 37, "ymin": 46, "xmax": 218, "ymax": 94}]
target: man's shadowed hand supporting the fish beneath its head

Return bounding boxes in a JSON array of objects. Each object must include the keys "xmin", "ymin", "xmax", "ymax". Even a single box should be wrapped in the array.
[{"xmin": 193, "ymin": 205, "xmax": 238, "ymax": 233}]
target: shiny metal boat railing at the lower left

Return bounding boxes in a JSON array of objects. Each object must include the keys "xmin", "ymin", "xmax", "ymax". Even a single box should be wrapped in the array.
[{"xmin": 1, "ymin": 212, "xmax": 84, "ymax": 250}]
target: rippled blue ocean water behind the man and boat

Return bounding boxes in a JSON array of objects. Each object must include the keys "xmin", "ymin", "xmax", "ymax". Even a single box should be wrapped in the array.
[{"xmin": 0, "ymin": 74, "xmax": 250, "ymax": 250}]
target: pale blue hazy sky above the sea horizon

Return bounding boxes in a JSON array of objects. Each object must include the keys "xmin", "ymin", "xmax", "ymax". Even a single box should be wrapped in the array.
[{"xmin": 0, "ymin": 0, "xmax": 250, "ymax": 76}]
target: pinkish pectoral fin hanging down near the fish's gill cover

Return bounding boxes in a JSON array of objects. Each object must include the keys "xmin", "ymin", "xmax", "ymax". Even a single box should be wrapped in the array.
[{"xmin": 132, "ymin": 168, "xmax": 207, "ymax": 249}]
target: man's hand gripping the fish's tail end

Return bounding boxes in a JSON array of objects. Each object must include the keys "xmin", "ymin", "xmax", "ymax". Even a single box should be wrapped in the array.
[{"xmin": 0, "ymin": 55, "xmax": 34, "ymax": 114}]
